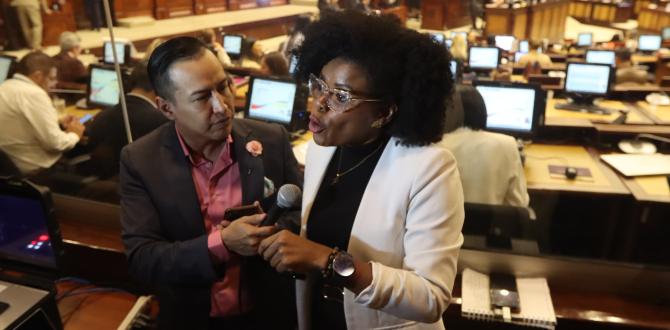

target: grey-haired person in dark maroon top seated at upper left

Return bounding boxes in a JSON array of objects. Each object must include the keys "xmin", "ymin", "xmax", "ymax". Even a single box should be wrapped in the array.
[{"xmin": 53, "ymin": 31, "xmax": 88, "ymax": 90}]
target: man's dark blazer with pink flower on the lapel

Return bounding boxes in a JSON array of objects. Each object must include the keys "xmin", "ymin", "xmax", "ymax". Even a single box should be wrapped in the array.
[{"xmin": 120, "ymin": 119, "xmax": 302, "ymax": 329}]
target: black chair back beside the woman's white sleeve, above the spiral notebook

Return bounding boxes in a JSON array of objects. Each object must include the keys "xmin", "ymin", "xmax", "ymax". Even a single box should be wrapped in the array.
[{"xmin": 463, "ymin": 203, "xmax": 539, "ymax": 254}]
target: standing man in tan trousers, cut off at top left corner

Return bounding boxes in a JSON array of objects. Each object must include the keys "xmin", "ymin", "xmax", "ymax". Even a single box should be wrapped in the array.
[{"xmin": 9, "ymin": 0, "xmax": 52, "ymax": 50}]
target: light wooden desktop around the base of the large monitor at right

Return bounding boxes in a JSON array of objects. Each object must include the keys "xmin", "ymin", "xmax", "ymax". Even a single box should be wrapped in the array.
[{"xmin": 544, "ymin": 98, "xmax": 654, "ymax": 127}]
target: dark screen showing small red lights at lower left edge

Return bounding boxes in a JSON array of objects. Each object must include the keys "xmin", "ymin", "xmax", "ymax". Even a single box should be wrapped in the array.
[{"xmin": 0, "ymin": 181, "xmax": 63, "ymax": 271}]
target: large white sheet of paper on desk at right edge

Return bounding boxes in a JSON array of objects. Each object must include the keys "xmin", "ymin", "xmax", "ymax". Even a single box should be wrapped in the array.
[{"xmin": 600, "ymin": 154, "xmax": 670, "ymax": 177}]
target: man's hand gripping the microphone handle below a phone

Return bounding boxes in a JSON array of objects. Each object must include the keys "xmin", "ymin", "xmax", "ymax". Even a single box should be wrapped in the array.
[{"xmin": 221, "ymin": 214, "xmax": 277, "ymax": 256}]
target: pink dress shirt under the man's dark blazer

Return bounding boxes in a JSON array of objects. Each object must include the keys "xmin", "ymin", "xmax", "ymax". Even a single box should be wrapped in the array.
[{"xmin": 177, "ymin": 130, "xmax": 249, "ymax": 317}]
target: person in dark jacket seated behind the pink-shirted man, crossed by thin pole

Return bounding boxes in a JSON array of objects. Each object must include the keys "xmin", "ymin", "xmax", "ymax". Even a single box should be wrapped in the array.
[{"xmin": 86, "ymin": 62, "xmax": 168, "ymax": 178}]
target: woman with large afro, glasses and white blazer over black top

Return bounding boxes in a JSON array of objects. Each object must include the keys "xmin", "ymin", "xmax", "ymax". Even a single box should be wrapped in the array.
[{"xmin": 259, "ymin": 12, "xmax": 463, "ymax": 329}]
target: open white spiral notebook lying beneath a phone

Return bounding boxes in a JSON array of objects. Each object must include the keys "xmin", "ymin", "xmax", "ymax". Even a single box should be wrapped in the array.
[{"xmin": 461, "ymin": 269, "xmax": 556, "ymax": 330}]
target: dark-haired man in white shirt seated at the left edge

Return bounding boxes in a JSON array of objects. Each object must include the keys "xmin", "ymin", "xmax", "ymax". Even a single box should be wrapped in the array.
[{"xmin": 0, "ymin": 52, "xmax": 84, "ymax": 175}]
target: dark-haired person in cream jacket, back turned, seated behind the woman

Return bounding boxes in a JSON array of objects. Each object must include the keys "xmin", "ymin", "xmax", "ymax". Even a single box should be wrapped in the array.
[{"xmin": 440, "ymin": 85, "xmax": 529, "ymax": 207}]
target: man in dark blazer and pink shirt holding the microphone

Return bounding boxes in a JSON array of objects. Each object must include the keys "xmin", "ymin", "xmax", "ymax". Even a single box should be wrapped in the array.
[{"xmin": 120, "ymin": 37, "xmax": 301, "ymax": 329}]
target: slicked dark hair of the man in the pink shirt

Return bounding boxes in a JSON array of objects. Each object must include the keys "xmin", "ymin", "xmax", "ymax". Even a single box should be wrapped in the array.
[{"xmin": 147, "ymin": 37, "xmax": 207, "ymax": 101}]
